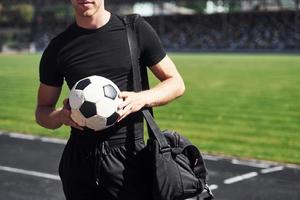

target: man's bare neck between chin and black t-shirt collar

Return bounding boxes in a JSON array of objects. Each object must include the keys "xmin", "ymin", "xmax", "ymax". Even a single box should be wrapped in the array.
[{"xmin": 75, "ymin": 10, "xmax": 111, "ymax": 29}]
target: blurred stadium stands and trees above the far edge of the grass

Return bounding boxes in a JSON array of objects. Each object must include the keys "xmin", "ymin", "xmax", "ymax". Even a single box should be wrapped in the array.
[{"xmin": 0, "ymin": 0, "xmax": 300, "ymax": 52}]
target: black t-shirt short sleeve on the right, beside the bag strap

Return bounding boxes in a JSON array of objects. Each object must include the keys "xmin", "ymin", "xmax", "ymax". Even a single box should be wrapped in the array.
[{"xmin": 136, "ymin": 17, "xmax": 166, "ymax": 67}]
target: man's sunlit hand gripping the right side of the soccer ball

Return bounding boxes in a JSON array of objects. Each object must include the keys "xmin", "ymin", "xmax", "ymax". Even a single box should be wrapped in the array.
[{"xmin": 118, "ymin": 91, "xmax": 147, "ymax": 122}]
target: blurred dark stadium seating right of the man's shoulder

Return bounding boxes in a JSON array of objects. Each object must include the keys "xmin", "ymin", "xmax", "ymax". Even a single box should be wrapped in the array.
[{"xmin": 147, "ymin": 11, "xmax": 300, "ymax": 51}]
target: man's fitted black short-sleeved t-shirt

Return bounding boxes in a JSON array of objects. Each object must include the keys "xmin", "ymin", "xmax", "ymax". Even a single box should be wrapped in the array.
[{"xmin": 40, "ymin": 14, "xmax": 166, "ymax": 137}]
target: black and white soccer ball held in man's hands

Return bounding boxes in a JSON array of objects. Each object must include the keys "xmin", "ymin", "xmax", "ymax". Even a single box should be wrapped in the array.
[{"xmin": 69, "ymin": 76, "xmax": 122, "ymax": 131}]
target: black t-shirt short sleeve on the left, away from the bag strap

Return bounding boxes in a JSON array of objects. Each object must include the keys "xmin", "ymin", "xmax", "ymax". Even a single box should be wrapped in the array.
[{"xmin": 39, "ymin": 42, "xmax": 64, "ymax": 87}]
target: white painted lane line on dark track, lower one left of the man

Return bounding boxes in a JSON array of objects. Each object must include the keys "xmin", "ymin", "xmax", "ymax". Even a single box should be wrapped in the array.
[{"xmin": 0, "ymin": 165, "xmax": 60, "ymax": 181}]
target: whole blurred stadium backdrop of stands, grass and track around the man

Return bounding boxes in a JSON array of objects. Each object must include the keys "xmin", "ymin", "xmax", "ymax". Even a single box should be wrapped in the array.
[{"xmin": 0, "ymin": 0, "xmax": 300, "ymax": 200}]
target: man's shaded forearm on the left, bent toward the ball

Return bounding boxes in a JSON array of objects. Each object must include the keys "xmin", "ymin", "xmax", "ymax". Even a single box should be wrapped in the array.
[{"xmin": 35, "ymin": 106, "xmax": 62, "ymax": 129}]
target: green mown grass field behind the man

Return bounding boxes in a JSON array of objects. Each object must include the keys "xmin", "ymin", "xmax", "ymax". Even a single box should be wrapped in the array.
[{"xmin": 0, "ymin": 54, "xmax": 300, "ymax": 164}]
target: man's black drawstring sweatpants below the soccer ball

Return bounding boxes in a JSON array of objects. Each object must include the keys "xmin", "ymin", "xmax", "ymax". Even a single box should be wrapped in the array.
[{"xmin": 59, "ymin": 134, "xmax": 151, "ymax": 200}]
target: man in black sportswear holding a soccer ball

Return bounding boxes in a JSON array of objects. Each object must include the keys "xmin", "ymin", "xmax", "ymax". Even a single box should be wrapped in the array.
[{"xmin": 36, "ymin": 0, "xmax": 185, "ymax": 200}]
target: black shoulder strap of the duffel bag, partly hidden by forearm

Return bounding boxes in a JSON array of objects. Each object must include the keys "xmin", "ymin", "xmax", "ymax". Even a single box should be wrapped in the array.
[{"xmin": 122, "ymin": 14, "xmax": 171, "ymax": 152}]
